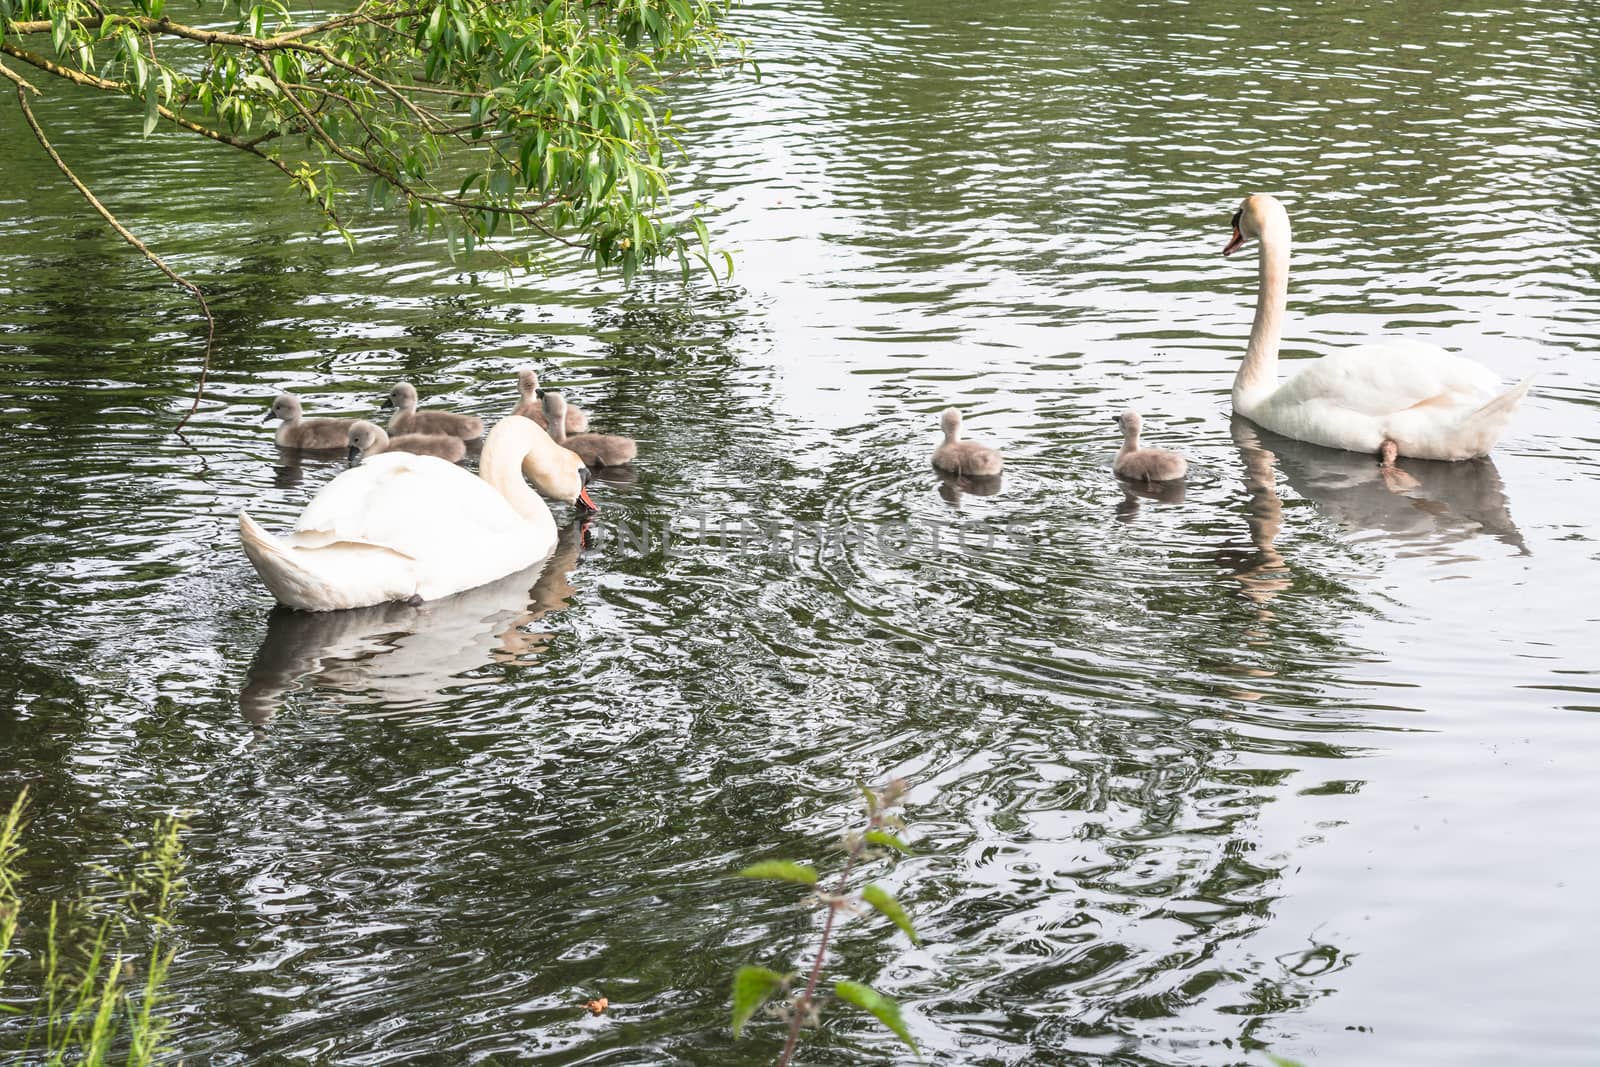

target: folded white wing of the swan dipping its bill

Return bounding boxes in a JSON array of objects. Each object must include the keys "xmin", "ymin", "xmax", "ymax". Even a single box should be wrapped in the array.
[{"xmin": 294, "ymin": 453, "xmax": 526, "ymax": 561}]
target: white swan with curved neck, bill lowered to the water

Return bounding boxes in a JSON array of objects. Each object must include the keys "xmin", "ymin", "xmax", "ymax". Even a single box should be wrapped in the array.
[{"xmin": 238, "ymin": 416, "xmax": 594, "ymax": 611}]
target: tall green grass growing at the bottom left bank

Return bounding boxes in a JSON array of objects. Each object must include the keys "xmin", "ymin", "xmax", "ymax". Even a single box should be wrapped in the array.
[{"xmin": 0, "ymin": 792, "xmax": 186, "ymax": 1067}]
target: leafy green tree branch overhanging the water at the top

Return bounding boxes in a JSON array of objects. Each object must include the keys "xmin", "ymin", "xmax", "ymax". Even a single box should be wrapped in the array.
[{"xmin": 0, "ymin": 0, "xmax": 747, "ymax": 429}]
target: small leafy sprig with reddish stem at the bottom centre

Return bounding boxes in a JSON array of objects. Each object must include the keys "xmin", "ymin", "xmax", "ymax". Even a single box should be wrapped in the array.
[{"xmin": 733, "ymin": 779, "xmax": 922, "ymax": 1067}]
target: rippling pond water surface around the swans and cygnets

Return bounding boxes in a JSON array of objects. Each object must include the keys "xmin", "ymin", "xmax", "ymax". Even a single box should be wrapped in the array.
[{"xmin": 0, "ymin": 0, "xmax": 1600, "ymax": 1064}]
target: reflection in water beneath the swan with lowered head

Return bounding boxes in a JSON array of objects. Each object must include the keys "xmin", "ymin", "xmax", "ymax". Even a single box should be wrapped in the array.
[{"xmin": 238, "ymin": 522, "xmax": 582, "ymax": 726}]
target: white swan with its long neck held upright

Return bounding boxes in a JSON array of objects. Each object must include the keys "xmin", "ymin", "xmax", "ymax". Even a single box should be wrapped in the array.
[{"xmin": 1222, "ymin": 194, "xmax": 1533, "ymax": 466}]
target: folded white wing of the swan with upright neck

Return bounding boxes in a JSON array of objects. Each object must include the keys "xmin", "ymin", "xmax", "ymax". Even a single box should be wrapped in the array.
[{"xmin": 1270, "ymin": 341, "xmax": 1501, "ymax": 416}]
